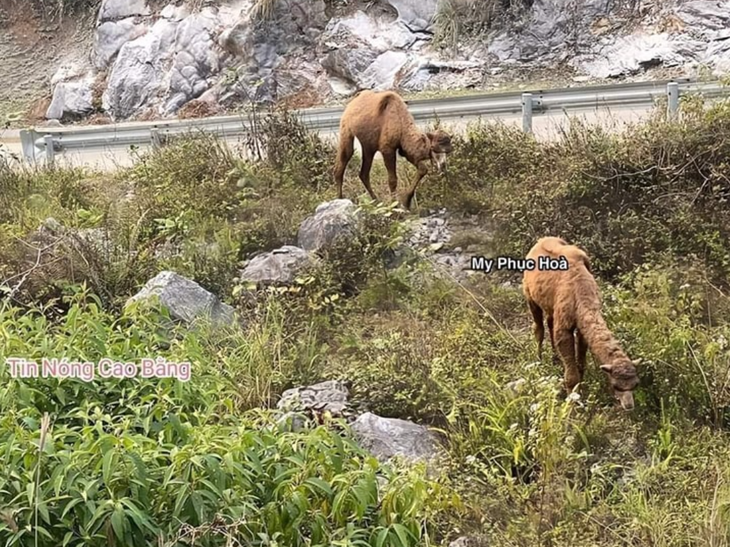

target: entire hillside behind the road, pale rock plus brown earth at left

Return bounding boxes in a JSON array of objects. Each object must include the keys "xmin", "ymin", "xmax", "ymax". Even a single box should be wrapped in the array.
[{"xmin": 0, "ymin": 0, "xmax": 730, "ymax": 123}]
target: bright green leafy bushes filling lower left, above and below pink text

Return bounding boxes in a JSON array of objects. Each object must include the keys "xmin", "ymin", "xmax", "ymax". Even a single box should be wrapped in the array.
[{"xmin": 0, "ymin": 293, "xmax": 451, "ymax": 546}]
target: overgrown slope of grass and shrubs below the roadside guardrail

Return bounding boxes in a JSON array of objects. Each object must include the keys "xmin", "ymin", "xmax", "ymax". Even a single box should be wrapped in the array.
[{"xmin": 0, "ymin": 99, "xmax": 730, "ymax": 547}]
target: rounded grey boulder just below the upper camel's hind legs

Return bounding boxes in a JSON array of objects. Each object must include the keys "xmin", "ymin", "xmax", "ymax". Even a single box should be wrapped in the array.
[{"xmin": 297, "ymin": 199, "xmax": 357, "ymax": 252}]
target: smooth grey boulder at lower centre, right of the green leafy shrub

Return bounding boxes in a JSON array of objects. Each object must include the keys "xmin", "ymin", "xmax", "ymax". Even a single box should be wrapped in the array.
[{"xmin": 352, "ymin": 412, "xmax": 439, "ymax": 462}]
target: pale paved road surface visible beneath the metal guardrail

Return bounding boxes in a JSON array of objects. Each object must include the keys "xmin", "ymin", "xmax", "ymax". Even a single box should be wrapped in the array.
[{"xmin": 0, "ymin": 103, "xmax": 651, "ymax": 171}]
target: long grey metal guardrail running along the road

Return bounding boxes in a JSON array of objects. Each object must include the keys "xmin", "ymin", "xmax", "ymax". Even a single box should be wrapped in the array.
[{"xmin": 20, "ymin": 79, "xmax": 730, "ymax": 161}]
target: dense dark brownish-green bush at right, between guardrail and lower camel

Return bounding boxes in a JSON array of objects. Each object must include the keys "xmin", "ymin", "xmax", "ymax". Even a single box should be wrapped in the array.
[{"xmin": 492, "ymin": 103, "xmax": 730, "ymax": 279}]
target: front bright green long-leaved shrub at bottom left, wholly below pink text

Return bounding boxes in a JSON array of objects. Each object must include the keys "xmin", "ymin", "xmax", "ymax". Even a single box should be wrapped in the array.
[{"xmin": 0, "ymin": 412, "xmax": 452, "ymax": 546}]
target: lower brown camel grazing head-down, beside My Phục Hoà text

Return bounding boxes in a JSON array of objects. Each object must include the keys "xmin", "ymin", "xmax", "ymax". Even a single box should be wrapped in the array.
[{"xmin": 522, "ymin": 237, "xmax": 639, "ymax": 410}]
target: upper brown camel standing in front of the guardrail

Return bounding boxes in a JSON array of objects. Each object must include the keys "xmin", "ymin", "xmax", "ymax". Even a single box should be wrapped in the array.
[{"xmin": 334, "ymin": 90, "xmax": 452, "ymax": 209}]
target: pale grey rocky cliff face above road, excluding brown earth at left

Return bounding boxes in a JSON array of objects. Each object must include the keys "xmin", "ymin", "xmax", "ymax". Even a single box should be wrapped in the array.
[{"xmin": 39, "ymin": 0, "xmax": 730, "ymax": 120}]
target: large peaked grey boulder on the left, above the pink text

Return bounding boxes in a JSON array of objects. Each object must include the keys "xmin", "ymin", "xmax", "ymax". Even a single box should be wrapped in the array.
[{"xmin": 126, "ymin": 271, "xmax": 235, "ymax": 325}]
